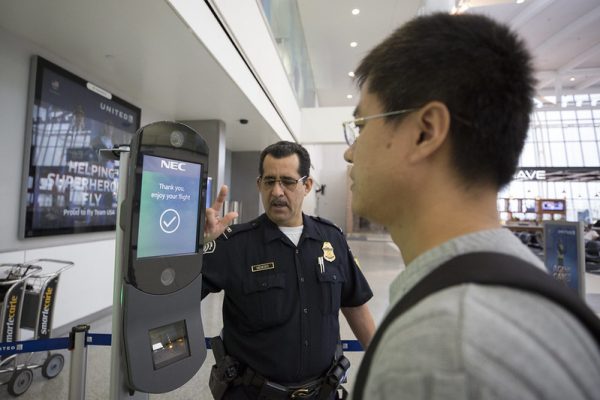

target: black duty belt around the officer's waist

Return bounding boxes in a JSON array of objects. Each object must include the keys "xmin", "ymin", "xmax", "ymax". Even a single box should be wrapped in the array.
[{"xmin": 233, "ymin": 366, "xmax": 324, "ymax": 400}]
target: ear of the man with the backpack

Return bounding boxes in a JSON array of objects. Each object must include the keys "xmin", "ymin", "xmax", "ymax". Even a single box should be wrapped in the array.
[{"xmin": 410, "ymin": 101, "xmax": 450, "ymax": 162}]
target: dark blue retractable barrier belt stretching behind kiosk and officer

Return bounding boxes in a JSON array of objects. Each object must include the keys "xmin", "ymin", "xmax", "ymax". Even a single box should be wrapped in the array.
[{"xmin": 0, "ymin": 333, "xmax": 363, "ymax": 356}]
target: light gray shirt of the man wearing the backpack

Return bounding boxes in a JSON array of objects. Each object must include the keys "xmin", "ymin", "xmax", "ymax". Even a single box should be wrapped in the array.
[{"xmin": 364, "ymin": 229, "xmax": 600, "ymax": 400}]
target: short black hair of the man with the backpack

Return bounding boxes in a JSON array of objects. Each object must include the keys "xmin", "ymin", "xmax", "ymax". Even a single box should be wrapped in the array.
[{"xmin": 355, "ymin": 13, "xmax": 535, "ymax": 188}]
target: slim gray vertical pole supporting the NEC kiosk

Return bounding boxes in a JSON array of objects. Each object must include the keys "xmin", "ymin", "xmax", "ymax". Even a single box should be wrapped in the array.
[{"xmin": 109, "ymin": 146, "xmax": 149, "ymax": 400}]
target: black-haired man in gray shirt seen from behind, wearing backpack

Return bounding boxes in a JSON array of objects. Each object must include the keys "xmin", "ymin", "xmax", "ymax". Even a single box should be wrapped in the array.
[{"xmin": 344, "ymin": 14, "xmax": 600, "ymax": 400}]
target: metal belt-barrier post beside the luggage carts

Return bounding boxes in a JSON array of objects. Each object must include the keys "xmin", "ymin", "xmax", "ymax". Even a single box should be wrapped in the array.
[{"xmin": 69, "ymin": 325, "xmax": 90, "ymax": 400}]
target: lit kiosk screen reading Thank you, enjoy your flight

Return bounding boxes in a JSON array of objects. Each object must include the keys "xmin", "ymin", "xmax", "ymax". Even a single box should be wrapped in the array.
[{"xmin": 137, "ymin": 154, "xmax": 204, "ymax": 258}]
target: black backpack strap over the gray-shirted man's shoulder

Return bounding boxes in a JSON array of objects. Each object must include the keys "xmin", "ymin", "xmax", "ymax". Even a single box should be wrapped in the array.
[{"xmin": 352, "ymin": 252, "xmax": 600, "ymax": 400}]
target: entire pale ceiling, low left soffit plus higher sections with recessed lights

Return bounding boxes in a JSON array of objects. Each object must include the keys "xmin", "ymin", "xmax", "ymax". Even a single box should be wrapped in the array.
[{"xmin": 0, "ymin": 0, "xmax": 600, "ymax": 151}]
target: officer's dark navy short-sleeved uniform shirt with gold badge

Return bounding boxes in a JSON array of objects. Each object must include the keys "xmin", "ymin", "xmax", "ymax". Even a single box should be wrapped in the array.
[{"xmin": 202, "ymin": 214, "xmax": 373, "ymax": 384}]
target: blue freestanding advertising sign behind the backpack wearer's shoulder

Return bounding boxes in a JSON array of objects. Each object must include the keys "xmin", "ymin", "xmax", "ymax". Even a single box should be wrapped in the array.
[{"xmin": 544, "ymin": 221, "xmax": 585, "ymax": 297}]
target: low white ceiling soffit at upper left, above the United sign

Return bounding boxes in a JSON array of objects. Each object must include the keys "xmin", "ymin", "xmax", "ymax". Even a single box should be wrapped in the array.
[{"xmin": 0, "ymin": 0, "xmax": 278, "ymax": 151}]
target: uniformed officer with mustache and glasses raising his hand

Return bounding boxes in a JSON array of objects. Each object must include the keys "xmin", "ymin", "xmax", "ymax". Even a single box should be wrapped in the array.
[{"xmin": 202, "ymin": 141, "xmax": 375, "ymax": 399}]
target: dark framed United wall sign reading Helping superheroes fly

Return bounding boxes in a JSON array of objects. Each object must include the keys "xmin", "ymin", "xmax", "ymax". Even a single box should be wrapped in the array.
[{"xmin": 20, "ymin": 56, "xmax": 141, "ymax": 238}]
